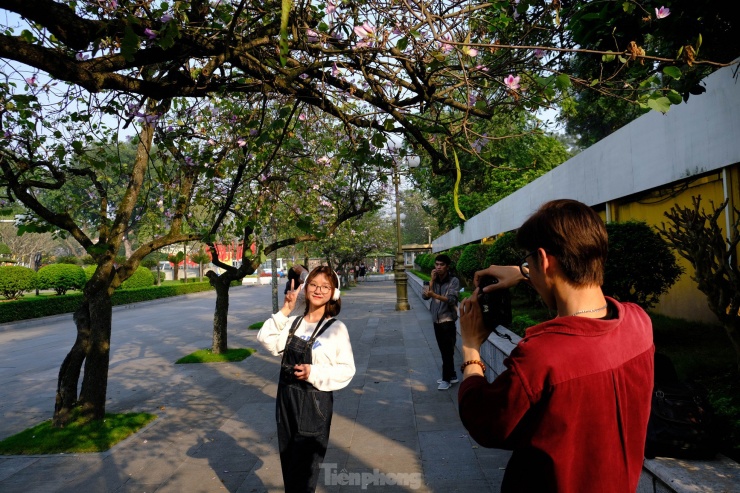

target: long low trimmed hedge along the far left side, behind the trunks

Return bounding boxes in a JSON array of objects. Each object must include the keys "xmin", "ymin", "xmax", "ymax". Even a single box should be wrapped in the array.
[{"xmin": 0, "ymin": 278, "xmax": 218, "ymax": 323}]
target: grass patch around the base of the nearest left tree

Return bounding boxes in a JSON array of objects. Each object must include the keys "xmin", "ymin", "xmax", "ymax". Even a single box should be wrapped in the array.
[{"xmin": 0, "ymin": 413, "xmax": 156, "ymax": 455}]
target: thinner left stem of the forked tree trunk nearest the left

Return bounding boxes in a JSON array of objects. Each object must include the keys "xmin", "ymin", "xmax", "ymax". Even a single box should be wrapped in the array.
[{"xmin": 52, "ymin": 301, "xmax": 90, "ymax": 428}]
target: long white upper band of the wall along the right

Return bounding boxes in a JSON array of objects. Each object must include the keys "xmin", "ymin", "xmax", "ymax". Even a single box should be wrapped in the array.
[{"xmin": 432, "ymin": 62, "xmax": 740, "ymax": 252}]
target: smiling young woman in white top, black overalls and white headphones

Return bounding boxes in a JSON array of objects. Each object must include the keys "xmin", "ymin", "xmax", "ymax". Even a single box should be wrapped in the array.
[{"xmin": 257, "ymin": 266, "xmax": 355, "ymax": 493}]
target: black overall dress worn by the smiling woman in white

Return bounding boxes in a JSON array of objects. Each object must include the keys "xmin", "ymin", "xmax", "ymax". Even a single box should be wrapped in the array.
[{"xmin": 276, "ymin": 316, "xmax": 335, "ymax": 493}]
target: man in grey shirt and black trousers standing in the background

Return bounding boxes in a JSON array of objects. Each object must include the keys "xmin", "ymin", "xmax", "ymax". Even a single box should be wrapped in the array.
[{"xmin": 422, "ymin": 254, "xmax": 460, "ymax": 390}]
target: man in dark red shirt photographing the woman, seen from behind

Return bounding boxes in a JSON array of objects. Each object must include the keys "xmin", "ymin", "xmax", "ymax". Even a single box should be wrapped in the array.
[{"xmin": 458, "ymin": 200, "xmax": 655, "ymax": 493}]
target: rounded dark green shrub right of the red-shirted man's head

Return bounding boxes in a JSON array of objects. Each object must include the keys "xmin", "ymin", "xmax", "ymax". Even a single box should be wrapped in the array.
[{"xmin": 603, "ymin": 221, "xmax": 683, "ymax": 309}]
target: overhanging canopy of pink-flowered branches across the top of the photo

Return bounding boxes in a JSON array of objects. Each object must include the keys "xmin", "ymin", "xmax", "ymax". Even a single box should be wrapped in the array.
[{"xmin": 0, "ymin": 0, "xmax": 728, "ymax": 172}]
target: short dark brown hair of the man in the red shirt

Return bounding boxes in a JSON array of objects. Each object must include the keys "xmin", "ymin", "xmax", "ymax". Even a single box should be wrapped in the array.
[{"xmin": 516, "ymin": 199, "xmax": 609, "ymax": 286}]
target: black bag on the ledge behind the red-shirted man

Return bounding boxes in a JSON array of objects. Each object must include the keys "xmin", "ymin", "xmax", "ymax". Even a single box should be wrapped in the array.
[{"xmin": 645, "ymin": 354, "xmax": 719, "ymax": 459}]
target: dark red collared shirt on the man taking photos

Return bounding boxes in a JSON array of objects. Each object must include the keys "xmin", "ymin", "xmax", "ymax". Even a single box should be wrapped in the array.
[{"xmin": 458, "ymin": 298, "xmax": 655, "ymax": 493}]
